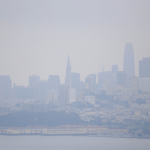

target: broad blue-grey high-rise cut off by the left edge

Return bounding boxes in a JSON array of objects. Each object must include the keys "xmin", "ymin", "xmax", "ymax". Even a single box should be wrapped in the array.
[{"xmin": 0, "ymin": 75, "xmax": 11, "ymax": 100}]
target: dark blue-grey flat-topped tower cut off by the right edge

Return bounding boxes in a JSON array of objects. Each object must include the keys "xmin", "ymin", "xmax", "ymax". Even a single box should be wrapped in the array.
[{"xmin": 139, "ymin": 58, "xmax": 150, "ymax": 78}]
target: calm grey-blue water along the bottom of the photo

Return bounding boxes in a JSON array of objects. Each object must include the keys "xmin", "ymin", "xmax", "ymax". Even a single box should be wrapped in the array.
[{"xmin": 0, "ymin": 135, "xmax": 150, "ymax": 150}]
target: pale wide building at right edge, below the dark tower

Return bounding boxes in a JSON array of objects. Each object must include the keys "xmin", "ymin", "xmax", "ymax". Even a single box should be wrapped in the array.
[{"xmin": 139, "ymin": 78, "xmax": 150, "ymax": 92}]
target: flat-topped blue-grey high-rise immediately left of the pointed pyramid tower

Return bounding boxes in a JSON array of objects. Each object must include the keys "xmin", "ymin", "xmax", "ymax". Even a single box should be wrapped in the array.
[{"xmin": 48, "ymin": 75, "xmax": 60, "ymax": 94}]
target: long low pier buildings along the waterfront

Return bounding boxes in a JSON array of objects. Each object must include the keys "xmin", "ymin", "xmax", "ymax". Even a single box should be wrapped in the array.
[{"xmin": 0, "ymin": 126, "xmax": 128, "ymax": 136}]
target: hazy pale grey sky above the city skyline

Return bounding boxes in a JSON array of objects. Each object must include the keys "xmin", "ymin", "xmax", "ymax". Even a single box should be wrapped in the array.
[{"xmin": 0, "ymin": 0, "xmax": 150, "ymax": 86}]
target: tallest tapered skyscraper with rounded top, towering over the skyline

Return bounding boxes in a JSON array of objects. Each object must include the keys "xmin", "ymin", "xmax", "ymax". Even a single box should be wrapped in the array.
[{"xmin": 123, "ymin": 43, "xmax": 135, "ymax": 78}]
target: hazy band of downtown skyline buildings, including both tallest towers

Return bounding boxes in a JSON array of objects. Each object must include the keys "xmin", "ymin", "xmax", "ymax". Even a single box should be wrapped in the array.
[{"xmin": 0, "ymin": 43, "xmax": 150, "ymax": 109}]
